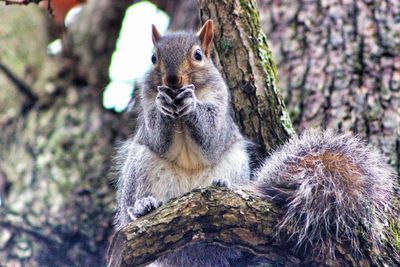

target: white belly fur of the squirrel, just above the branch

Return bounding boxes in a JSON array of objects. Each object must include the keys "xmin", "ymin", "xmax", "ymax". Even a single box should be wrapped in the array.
[{"xmin": 131, "ymin": 142, "xmax": 249, "ymax": 202}]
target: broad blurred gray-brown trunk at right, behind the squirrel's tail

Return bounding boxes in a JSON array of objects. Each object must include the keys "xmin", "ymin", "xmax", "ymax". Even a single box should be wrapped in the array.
[{"xmin": 259, "ymin": 0, "xmax": 400, "ymax": 173}]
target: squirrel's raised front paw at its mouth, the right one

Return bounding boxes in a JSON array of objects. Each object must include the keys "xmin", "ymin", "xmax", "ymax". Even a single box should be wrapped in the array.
[{"xmin": 174, "ymin": 84, "xmax": 197, "ymax": 117}]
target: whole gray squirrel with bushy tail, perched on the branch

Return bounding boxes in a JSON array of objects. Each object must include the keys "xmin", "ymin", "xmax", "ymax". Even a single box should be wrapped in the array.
[{"xmin": 111, "ymin": 20, "xmax": 395, "ymax": 266}]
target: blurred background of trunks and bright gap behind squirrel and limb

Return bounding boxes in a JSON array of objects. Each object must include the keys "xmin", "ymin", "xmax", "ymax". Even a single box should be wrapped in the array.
[{"xmin": 0, "ymin": 0, "xmax": 400, "ymax": 266}]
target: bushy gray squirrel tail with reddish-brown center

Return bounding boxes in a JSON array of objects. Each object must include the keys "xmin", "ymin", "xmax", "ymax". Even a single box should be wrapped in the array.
[{"xmin": 256, "ymin": 131, "xmax": 396, "ymax": 257}]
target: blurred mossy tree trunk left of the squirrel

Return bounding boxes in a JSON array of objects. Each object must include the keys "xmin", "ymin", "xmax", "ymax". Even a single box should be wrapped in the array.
[{"xmin": 0, "ymin": 1, "xmax": 130, "ymax": 266}]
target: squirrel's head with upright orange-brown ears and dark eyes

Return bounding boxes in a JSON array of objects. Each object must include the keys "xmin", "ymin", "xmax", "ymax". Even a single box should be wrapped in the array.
[{"xmin": 151, "ymin": 20, "xmax": 214, "ymax": 89}]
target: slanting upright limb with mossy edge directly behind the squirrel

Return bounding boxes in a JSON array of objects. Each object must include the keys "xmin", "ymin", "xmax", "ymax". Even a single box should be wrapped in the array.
[{"xmin": 199, "ymin": 0, "xmax": 294, "ymax": 163}]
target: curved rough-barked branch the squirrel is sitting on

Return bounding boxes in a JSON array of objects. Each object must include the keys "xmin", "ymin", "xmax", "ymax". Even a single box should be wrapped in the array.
[{"xmin": 109, "ymin": 188, "xmax": 400, "ymax": 266}]
